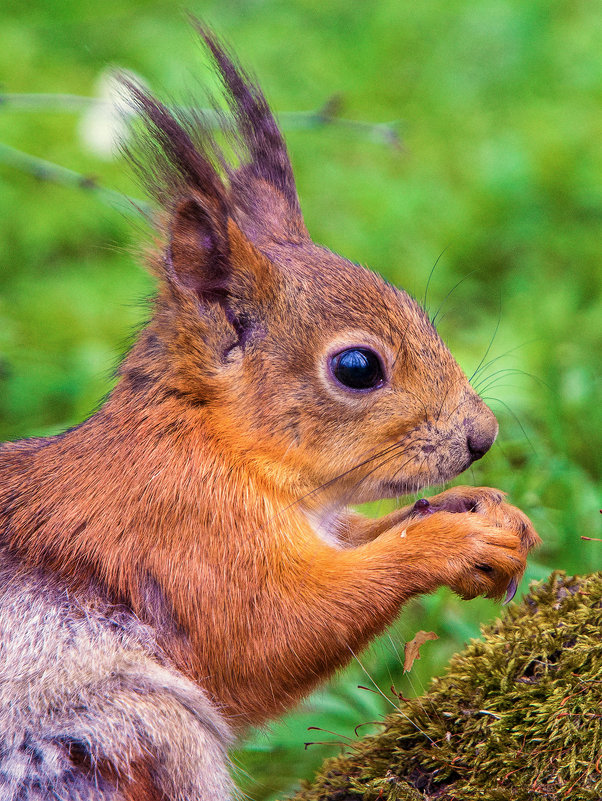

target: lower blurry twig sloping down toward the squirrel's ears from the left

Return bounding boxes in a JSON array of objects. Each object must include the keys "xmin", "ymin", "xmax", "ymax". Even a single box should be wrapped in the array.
[{"xmin": 0, "ymin": 142, "xmax": 151, "ymax": 215}]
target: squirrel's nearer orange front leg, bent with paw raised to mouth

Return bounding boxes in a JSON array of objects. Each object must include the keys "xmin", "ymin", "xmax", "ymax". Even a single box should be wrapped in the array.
[{"xmin": 241, "ymin": 504, "xmax": 526, "ymax": 722}]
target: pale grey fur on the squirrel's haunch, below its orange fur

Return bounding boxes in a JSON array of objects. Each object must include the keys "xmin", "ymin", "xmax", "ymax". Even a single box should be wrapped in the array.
[{"xmin": 0, "ymin": 554, "xmax": 232, "ymax": 801}]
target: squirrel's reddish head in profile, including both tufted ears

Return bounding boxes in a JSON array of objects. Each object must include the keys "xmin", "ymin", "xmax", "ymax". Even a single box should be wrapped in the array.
[{"xmin": 120, "ymin": 25, "xmax": 497, "ymax": 506}]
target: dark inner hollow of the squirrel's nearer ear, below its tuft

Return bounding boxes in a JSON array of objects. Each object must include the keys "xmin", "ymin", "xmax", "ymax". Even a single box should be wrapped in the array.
[{"xmin": 167, "ymin": 196, "xmax": 231, "ymax": 302}]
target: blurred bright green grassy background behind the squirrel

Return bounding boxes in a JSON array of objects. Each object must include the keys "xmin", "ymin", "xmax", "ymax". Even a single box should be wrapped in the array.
[{"xmin": 0, "ymin": 0, "xmax": 602, "ymax": 801}]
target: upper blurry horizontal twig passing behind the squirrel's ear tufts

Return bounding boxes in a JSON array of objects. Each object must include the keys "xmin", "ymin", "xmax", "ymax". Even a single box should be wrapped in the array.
[{"xmin": 0, "ymin": 93, "xmax": 401, "ymax": 148}]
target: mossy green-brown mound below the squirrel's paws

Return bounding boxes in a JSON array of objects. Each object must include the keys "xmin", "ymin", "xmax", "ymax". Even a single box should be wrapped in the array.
[{"xmin": 295, "ymin": 572, "xmax": 602, "ymax": 801}]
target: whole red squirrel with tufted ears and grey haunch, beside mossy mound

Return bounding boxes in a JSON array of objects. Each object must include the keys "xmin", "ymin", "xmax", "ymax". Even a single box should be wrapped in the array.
[{"xmin": 0, "ymin": 23, "xmax": 539, "ymax": 801}]
